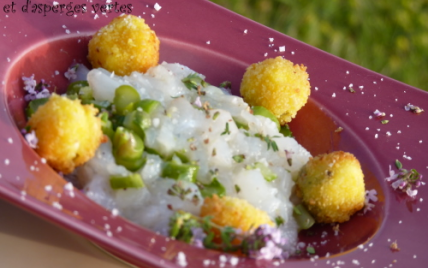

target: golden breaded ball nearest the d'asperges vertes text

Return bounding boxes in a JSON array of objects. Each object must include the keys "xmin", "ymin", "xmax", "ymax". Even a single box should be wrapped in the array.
[{"xmin": 88, "ymin": 15, "xmax": 159, "ymax": 76}]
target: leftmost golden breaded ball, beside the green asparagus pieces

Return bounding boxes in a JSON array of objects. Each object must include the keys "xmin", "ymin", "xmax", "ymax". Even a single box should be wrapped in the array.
[{"xmin": 28, "ymin": 94, "xmax": 103, "ymax": 174}]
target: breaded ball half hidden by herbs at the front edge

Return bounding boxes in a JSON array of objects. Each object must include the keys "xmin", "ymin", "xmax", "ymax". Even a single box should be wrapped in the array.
[{"xmin": 201, "ymin": 195, "xmax": 275, "ymax": 232}]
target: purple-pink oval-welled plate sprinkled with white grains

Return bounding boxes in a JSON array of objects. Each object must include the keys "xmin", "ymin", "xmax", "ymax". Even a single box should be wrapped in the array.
[{"xmin": 0, "ymin": 0, "xmax": 428, "ymax": 267}]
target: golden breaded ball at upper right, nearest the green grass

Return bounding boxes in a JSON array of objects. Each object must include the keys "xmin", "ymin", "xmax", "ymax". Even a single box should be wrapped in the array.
[{"xmin": 241, "ymin": 56, "xmax": 311, "ymax": 125}]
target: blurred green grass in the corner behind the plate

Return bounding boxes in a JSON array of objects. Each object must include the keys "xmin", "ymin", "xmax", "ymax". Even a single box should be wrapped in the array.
[{"xmin": 211, "ymin": 0, "xmax": 428, "ymax": 91}]
